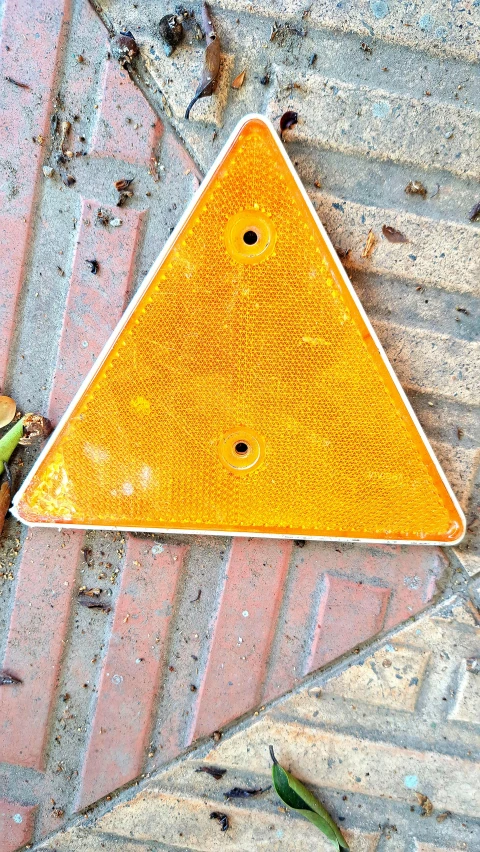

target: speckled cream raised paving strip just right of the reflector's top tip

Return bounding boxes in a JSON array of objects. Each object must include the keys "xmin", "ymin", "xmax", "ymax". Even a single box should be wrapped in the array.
[{"xmin": 268, "ymin": 69, "xmax": 480, "ymax": 177}]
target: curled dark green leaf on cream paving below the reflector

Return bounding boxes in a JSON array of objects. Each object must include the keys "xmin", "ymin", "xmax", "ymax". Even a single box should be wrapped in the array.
[{"xmin": 270, "ymin": 746, "xmax": 349, "ymax": 852}]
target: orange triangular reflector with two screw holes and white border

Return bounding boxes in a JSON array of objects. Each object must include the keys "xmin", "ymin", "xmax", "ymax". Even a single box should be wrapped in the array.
[{"xmin": 16, "ymin": 116, "xmax": 465, "ymax": 544}]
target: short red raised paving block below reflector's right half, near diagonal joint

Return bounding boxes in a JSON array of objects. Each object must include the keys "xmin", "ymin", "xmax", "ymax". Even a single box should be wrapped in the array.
[{"xmin": 305, "ymin": 574, "xmax": 391, "ymax": 674}]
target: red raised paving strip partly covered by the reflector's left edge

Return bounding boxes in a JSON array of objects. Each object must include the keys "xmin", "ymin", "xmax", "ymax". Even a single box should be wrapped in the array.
[{"xmin": 49, "ymin": 199, "xmax": 147, "ymax": 423}]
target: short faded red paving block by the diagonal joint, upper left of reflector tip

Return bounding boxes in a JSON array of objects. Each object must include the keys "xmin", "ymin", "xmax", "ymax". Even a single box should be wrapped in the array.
[{"xmin": 90, "ymin": 60, "xmax": 163, "ymax": 166}]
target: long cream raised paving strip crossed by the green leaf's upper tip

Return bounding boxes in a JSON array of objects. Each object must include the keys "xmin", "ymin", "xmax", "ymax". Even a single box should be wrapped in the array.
[{"xmin": 207, "ymin": 720, "xmax": 480, "ymax": 817}]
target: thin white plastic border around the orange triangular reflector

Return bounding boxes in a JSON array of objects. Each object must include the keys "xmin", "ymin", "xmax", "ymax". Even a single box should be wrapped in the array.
[{"xmin": 12, "ymin": 113, "xmax": 466, "ymax": 547}]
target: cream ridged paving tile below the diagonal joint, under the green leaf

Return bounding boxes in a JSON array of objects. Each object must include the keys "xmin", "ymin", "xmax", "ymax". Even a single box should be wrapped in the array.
[{"xmin": 38, "ymin": 598, "xmax": 480, "ymax": 852}]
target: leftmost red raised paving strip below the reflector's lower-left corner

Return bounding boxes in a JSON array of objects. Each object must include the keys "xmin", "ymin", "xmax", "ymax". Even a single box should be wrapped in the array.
[{"xmin": 0, "ymin": 529, "xmax": 83, "ymax": 770}]
